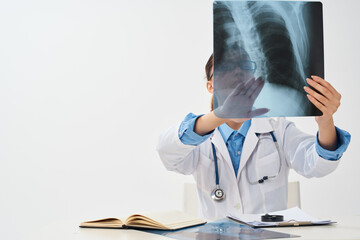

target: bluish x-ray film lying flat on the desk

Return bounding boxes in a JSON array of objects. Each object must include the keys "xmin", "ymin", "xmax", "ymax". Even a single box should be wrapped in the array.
[{"xmin": 142, "ymin": 218, "xmax": 299, "ymax": 240}]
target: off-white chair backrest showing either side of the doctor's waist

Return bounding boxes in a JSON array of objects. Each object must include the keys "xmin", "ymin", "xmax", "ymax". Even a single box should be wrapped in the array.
[{"xmin": 183, "ymin": 181, "xmax": 301, "ymax": 216}]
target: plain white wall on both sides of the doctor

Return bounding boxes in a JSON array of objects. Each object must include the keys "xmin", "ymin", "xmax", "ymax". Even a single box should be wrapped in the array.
[{"xmin": 0, "ymin": 0, "xmax": 360, "ymax": 239}]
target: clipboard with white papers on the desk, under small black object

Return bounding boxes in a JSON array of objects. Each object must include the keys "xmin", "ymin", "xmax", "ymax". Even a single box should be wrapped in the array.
[{"xmin": 227, "ymin": 207, "xmax": 333, "ymax": 228}]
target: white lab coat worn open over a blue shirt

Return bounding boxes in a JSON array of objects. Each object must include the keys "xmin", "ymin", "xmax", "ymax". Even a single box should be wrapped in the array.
[{"xmin": 157, "ymin": 118, "xmax": 339, "ymax": 219}]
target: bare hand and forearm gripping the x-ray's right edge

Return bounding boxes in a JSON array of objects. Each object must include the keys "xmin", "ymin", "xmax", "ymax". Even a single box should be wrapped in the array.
[{"xmin": 304, "ymin": 76, "xmax": 341, "ymax": 151}]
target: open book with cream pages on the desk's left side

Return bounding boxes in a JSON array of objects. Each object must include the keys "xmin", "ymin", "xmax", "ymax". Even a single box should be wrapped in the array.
[{"xmin": 80, "ymin": 211, "xmax": 206, "ymax": 230}]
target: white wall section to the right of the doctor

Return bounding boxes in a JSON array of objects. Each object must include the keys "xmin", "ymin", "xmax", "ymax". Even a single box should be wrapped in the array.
[{"xmin": 290, "ymin": 0, "xmax": 360, "ymax": 218}]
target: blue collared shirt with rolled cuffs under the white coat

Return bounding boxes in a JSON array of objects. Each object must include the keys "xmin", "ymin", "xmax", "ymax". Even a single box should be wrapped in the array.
[{"xmin": 179, "ymin": 113, "xmax": 351, "ymax": 175}]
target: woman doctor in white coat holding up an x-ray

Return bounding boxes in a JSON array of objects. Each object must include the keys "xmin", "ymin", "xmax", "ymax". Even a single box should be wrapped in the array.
[{"xmin": 157, "ymin": 55, "xmax": 350, "ymax": 219}]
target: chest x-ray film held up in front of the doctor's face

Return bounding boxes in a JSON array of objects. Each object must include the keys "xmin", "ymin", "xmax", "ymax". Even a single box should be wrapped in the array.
[{"xmin": 213, "ymin": 1, "xmax": 324, "ymax": 118}]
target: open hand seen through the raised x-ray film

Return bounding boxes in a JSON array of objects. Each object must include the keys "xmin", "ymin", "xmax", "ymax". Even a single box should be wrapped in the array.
[{"xmin": 214, "ymin": 77, "xmax": 269, "ymax": 122}]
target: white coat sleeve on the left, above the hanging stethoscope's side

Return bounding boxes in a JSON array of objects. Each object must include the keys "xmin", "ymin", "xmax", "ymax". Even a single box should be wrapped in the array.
[{"xmin": 156, "ymin": 124, "xmax": 200, "ymax": 175}]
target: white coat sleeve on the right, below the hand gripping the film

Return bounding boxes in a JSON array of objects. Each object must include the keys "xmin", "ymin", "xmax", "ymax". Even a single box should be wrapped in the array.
[{"xmin": 278, "ymin": 119, "xmax": 340, "ymax": 178}]
